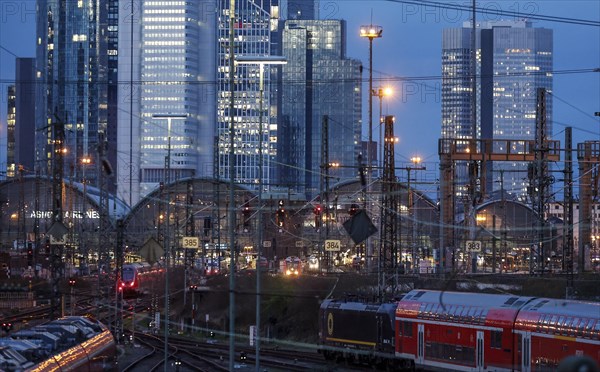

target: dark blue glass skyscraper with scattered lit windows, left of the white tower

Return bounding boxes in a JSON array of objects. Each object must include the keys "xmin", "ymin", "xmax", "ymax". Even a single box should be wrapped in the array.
[{"xmin": 35, "ymin": 0, "xmax": 119, "ymax": 190}]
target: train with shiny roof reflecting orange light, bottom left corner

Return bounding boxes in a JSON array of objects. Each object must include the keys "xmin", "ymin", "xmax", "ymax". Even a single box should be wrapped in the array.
[{"xmin": 0, "ymin": 316, "xmax": 118, "ymax": 372}]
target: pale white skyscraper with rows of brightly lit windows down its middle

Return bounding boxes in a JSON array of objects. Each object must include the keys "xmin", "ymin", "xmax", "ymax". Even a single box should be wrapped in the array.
[{"xmin": 117, "ymin": 0, "xmax": 216, "ymax": 205}]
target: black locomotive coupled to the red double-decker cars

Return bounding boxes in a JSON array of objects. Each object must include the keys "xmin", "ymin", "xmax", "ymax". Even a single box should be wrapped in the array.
[{"xmin": 319, "ymin": 300, "xmax": 396, "ymax": 365}]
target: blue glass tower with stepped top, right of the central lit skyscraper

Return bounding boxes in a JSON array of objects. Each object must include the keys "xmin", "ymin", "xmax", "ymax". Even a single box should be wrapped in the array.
[{"xmin": 278, "ymin": 20, "xmax": 362, "ymax": 197}]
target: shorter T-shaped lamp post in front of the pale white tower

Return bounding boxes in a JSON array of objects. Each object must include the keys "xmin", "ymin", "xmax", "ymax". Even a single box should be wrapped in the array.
[{"xmin": 152, "ymin": 114, "xmax": 187, "ymax": 372}]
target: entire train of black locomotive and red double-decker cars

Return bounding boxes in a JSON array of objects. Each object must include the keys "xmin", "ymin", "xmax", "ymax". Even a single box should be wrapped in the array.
[{"xmin": 319, "ymin": 290, "xmax": 600, "ymax": 372}]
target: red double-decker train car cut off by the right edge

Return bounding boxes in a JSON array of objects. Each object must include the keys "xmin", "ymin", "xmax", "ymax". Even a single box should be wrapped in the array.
[{"xmin": 514, "ymin": 298, "xmax": 600, "ymax": 372}]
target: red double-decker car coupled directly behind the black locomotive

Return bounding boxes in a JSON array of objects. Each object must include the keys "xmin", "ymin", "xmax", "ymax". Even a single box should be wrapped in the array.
[{"xmin": 396, "ymin": 290, "xmax": 531, "ymax": 371}]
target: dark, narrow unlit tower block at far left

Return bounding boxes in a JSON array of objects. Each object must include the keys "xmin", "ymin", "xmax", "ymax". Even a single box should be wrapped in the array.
[{"xmin": 14, "ymin": 58, "xmax": 36, "ymax": 174}]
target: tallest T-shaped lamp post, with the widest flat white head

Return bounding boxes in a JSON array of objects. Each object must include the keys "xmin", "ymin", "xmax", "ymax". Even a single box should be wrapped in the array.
[{"xmin": 235, "ymin": 56, "xmax": 287, "ymax": 372}]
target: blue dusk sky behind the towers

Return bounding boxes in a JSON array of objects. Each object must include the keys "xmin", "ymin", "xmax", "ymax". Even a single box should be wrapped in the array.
[{"xmin": 0, "ymin": 0, "xmax": 600, "ymax": 192}]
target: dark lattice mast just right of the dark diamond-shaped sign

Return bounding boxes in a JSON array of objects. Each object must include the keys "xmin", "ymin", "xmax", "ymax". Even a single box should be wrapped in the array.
[{"xmin": 379, "ymin": 116, "xmax": 399, "ymax": 297}]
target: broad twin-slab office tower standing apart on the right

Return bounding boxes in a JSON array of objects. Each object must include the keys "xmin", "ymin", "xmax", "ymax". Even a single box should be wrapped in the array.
[{"xmin": 442, "ymin": 21, "xmax": 553, "ymax": 198}]
